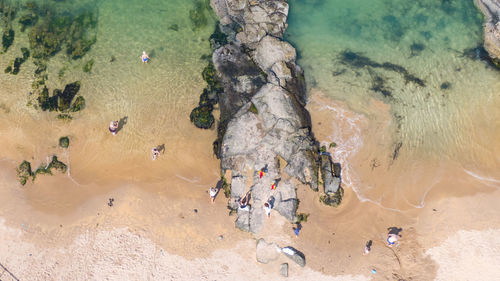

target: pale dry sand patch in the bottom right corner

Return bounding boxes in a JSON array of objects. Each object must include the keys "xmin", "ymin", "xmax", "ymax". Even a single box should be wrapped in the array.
[{"xmin": 426, "ymin": 229, "xmax": 500, "ymax": 281}]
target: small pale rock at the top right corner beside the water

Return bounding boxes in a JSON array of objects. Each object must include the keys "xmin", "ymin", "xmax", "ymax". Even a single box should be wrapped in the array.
[{"xmin": 474, "ymin": 0, "xmax": 500, "ymax": 59}]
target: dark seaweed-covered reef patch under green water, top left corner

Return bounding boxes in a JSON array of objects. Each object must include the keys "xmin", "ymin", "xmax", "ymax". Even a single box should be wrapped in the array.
[{"xmin": 0, "ymin": 1, "xmax": 97, "ymax": 117}]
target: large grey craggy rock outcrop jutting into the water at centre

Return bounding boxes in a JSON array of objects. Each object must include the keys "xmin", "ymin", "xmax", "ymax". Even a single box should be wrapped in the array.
[{"xmin": 200, "ymin": 0, "xmax": 343, "ymax": 233}]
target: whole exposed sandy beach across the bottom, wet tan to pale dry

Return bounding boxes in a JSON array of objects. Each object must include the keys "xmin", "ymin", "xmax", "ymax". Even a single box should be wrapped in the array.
[{"xmin": 0, "ymin": 88, "xmax": 500, "ymax": 280}]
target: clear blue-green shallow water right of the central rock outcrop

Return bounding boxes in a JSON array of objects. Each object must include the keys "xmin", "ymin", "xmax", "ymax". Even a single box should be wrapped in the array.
[{"xmin": 286, "ymin": 0, "xmax": 500, "ymax": 206}]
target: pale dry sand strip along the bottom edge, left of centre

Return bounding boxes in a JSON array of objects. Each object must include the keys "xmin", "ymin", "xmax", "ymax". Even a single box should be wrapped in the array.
[{"xmin": 0, "ymin": 219, "xmax": 369, "ymax": 281}]
